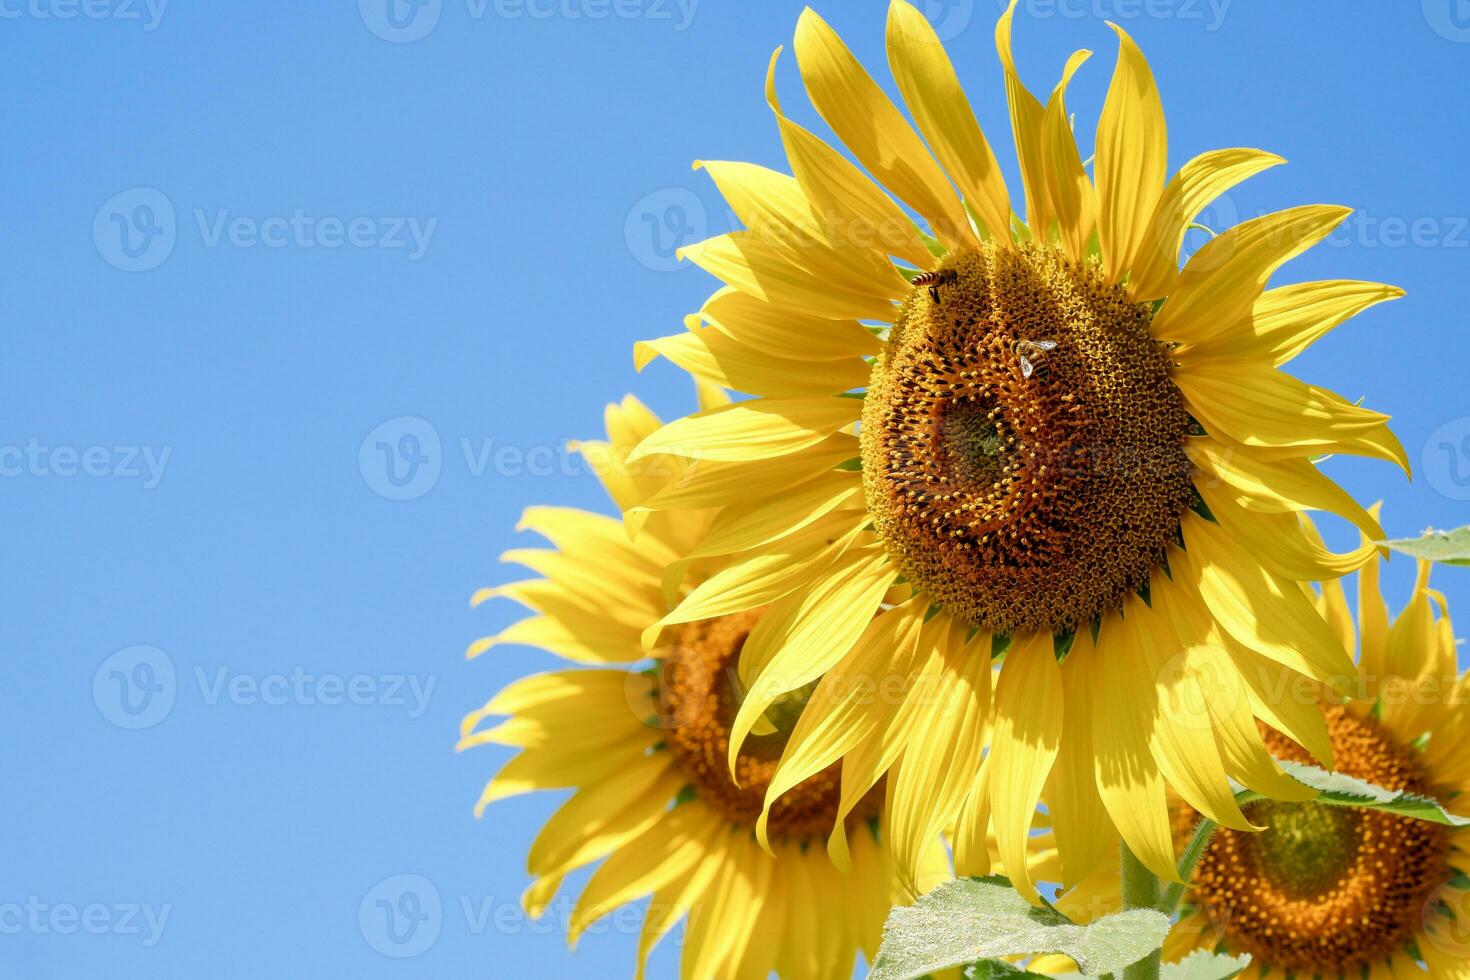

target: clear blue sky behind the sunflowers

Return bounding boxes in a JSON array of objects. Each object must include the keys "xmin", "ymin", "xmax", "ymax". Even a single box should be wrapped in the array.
[{"xmin": 0, "ymin": 0, "xmax": 1470, "ymax": 977}]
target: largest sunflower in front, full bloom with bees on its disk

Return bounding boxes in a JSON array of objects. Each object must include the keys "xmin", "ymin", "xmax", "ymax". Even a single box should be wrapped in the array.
[{"xmin": 634, "ymin": 0, "xmax": 1408, "ymax": 899}]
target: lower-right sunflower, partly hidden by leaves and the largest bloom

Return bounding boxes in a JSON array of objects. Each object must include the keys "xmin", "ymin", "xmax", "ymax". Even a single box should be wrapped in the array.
[{"xmin": 1058, "ymin": 543, "xmax": 1470, "ymax": 980}]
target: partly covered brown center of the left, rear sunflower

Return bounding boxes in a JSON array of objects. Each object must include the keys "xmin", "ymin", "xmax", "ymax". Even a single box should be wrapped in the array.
[{"xmin": 659, "ymin": 613, "xmax": 883, "ymax": 840}]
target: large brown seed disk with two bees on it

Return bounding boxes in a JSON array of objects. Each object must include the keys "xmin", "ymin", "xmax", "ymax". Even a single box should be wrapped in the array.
[{"xmin": 861, "ymin": 242, "xmax": 1194, "ymax": 633}]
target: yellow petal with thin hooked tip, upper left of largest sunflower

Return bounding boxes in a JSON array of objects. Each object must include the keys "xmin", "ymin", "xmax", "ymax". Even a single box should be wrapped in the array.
[{"xmin": 766, "ymin": 47, "xmax": 933, "ymax": 265}]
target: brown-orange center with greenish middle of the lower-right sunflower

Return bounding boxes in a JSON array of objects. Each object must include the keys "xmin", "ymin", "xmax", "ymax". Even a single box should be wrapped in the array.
[{"xmin": 1192, "ymin": 708, "xmax": 1451, "ymax": 976}]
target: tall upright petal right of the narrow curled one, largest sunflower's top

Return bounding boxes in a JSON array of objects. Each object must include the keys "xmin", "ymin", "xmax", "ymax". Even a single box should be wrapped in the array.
[{"xmin": 1097, "ymin": 22, "xmax": 1169, "ymax": 282}]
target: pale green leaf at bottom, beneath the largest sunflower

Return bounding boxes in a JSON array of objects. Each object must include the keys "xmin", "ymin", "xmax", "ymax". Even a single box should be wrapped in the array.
[{"xmin": 870, "ymin": 877, "xmax": 1169, "ymax": 980}]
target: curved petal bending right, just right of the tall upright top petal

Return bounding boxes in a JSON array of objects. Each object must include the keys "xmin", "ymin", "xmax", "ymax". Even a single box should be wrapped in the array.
[{"xmin": 1123, "ymin": 150, "xmax": 1285, "ymax": 301}]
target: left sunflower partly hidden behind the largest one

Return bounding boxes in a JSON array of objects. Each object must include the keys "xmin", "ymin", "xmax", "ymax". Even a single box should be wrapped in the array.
[{"xmin": 459, "ymin": 395, "xmax": 950, "ymax": 979}]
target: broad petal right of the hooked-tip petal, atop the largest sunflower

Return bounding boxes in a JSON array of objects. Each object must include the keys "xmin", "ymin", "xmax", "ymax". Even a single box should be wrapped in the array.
[{"xmin": 795, "ymin": 7, "xmax": 976, "ymax": 247}]
